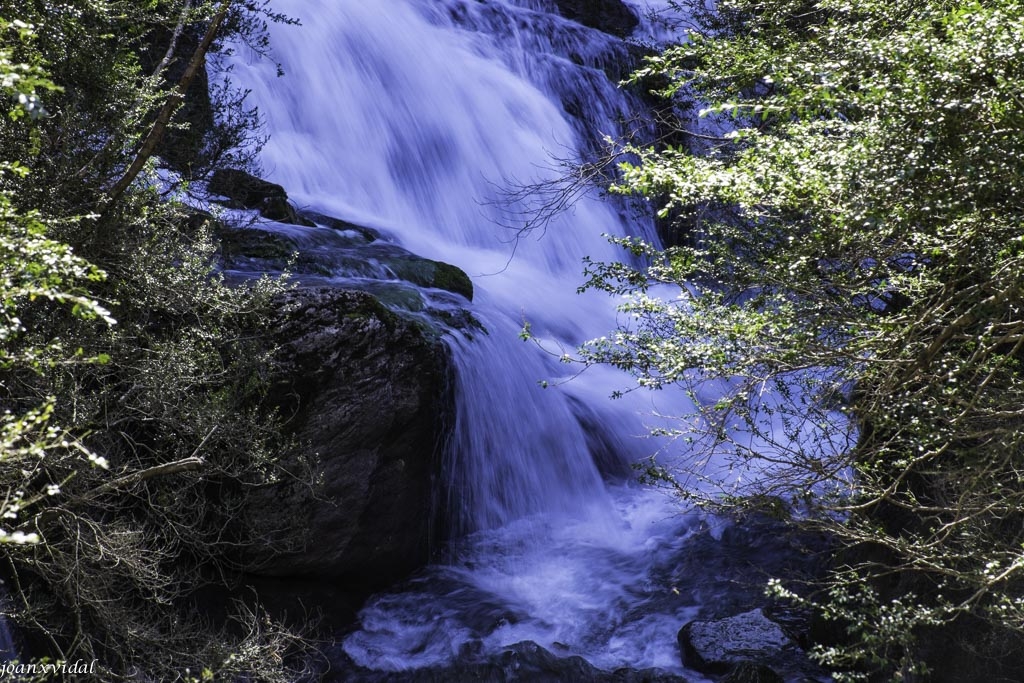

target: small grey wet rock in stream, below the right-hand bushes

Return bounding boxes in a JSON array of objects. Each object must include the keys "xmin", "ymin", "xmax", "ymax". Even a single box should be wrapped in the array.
[{"xmin": 679, "ymin": 609, "xmax": 798, "ymax": 683}]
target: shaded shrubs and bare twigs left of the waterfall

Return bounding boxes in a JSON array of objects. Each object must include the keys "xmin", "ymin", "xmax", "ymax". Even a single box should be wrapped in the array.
[{"xmin": 0, "ymin": 0, "xmax": 305, "ymax": 681}]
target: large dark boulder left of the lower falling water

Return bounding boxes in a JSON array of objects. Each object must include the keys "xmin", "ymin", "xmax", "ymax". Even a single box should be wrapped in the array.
[{"xmin": 243, "ymin": 288, "xmax": 450, "ymax": 595}]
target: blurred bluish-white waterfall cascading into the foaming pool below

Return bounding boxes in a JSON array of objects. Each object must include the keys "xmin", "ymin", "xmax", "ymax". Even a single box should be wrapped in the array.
[{"xmin": 233, "ymin": 0, "xmax": 745, "ymax": 671}]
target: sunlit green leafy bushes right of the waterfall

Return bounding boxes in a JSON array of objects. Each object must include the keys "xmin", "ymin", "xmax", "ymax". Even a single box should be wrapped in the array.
[{"xmin": 582, "ymin": 0, "xmax": 1024, "ymax": 680}]
